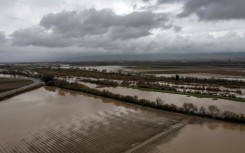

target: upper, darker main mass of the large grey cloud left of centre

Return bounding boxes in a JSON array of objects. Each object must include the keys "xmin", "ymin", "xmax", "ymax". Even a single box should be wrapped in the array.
[{"xmin": 40, "ymin": 9, "xmax": 167, "ymax": 39}]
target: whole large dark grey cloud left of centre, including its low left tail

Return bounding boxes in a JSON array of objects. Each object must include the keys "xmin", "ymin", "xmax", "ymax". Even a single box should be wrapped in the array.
[{"xmin": 12, "ymin": 9, "xmax": 173, "ymax": 47}]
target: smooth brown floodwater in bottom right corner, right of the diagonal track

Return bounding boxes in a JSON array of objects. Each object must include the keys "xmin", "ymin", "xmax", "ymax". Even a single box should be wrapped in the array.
[{"xmin": 139, "ymin": 121, "xmax": 245, "ymax": 153}]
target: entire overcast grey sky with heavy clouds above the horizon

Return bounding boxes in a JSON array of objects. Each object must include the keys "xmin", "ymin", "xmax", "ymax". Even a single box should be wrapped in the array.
[{"xmin": 0, "ymin": 0, "xmax": 245, "ymax": 62}]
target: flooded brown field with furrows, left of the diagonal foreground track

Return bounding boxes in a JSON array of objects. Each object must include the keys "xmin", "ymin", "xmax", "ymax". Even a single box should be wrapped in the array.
[{"xmin": 0, "ymin": 87, "xmax": 188, "ymax": 153}]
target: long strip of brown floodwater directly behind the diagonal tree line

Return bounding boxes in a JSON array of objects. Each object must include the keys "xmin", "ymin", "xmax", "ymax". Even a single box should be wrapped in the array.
[{"xmin": 98, "ymin": 87, "xmax": 245, "ymax": 113}]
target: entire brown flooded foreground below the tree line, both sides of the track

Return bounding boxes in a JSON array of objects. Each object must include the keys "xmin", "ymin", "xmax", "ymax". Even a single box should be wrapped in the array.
[{"xmin": 0, "ymin": 87, "xmax": 245, "ymax": 153}]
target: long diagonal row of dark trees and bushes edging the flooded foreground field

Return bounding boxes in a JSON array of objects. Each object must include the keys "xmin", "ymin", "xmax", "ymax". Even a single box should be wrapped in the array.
[{"xmin": 47, "ymin": 79, "xmax": 245, "ymax": 123}]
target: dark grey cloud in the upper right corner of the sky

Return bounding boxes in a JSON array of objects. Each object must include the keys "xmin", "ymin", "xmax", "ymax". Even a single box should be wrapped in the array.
[{"xmin": 158, "ymin": 0, "xmax": 245, "ymax": 20}]
